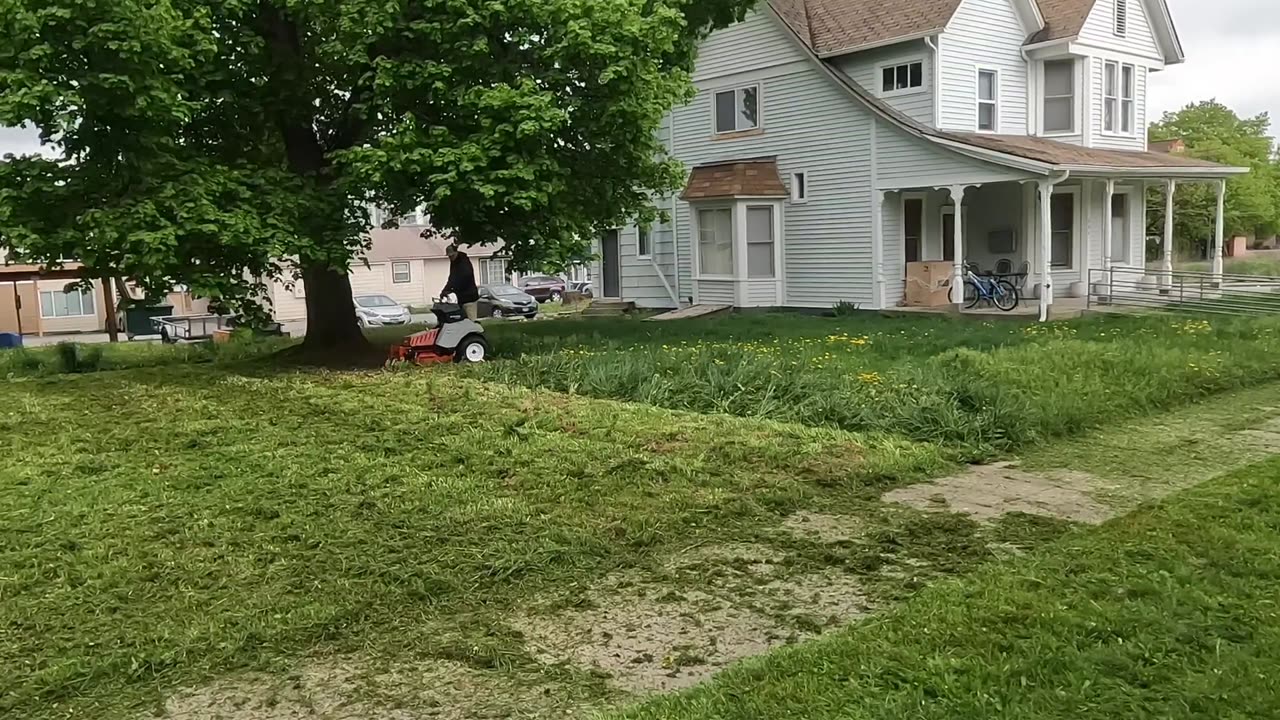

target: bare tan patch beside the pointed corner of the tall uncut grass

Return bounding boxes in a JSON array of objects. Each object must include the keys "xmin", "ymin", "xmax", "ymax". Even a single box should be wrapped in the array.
[{"xmin": 883, "ymin": 462, "xmax": 1115, "ymax": 523}]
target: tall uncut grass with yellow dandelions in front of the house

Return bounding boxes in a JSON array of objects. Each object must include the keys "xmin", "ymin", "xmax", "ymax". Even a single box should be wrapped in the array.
[{"xmin": 470, "ymin": 314, "xmax": 1280, "ymax": 460}]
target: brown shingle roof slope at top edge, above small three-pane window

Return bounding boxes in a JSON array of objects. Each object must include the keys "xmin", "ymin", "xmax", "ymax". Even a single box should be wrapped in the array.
[{"xmin": 803, "ymin": 0, "xmax": 961, "ymax": 55}]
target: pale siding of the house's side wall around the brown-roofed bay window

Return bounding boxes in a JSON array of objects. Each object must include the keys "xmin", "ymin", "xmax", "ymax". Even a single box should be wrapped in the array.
[{"xmin": 673, "ymin": 13, "xmax": 873, "ymax": 307}]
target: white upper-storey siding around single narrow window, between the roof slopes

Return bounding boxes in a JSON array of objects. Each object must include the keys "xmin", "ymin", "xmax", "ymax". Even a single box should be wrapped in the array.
[{"xmin": 938, "ymin": 0, "xmax": 1028, "ymax": 135}]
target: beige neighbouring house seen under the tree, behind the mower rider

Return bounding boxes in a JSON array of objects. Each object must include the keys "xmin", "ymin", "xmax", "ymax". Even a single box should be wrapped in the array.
[{"xmin": 269, "ymin": 215, "xmax": 509, "ymax": 317}]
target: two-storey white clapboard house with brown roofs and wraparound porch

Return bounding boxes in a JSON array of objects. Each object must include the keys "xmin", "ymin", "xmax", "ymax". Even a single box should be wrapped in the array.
[{"xmin": 593, "ymin": 0, "xmax": 1247, "ymax": 314}]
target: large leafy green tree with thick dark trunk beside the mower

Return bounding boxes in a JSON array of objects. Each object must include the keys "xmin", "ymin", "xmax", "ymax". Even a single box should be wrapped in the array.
[{"xmin": 0, "ymin": 0, "xmax": 754, "ymax": 350}]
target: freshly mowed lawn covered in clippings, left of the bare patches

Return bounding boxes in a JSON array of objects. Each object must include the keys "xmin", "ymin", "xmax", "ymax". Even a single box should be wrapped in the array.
[{"xmin": 0, "ymin": 365, "xmax": 952, "ymax": 720}]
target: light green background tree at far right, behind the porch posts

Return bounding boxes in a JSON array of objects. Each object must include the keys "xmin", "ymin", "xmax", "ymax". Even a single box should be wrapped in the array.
[{"xmin": 1147, "ymin": 100, "xmax": 1280, "ymax": 258}]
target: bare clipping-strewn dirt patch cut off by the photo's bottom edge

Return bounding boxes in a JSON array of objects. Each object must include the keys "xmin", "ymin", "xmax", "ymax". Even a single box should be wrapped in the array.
[{"xmin": 150, "ymin": 660, "xmax": 586, "ymax": 720}]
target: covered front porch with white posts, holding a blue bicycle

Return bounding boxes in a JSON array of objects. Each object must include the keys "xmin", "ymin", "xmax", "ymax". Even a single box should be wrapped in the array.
[{"xmin": 882, "ymin": 172, "xmax": 1225, "ymax": 319}]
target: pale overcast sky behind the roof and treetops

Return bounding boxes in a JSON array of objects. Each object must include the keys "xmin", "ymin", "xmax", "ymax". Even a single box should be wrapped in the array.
[{"xmin": 0, "ymin": 0, "xmax": 1280, "ymax": 155}]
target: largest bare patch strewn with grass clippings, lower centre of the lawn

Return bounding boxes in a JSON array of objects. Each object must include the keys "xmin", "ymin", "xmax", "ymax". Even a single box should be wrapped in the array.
[{"xmin": 518, "ymin": 544, "xmax": 869, "ymax": 693}]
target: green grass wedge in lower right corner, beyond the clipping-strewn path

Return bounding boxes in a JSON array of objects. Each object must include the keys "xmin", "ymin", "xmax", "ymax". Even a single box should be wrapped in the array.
[{"xmin": 620, "ymin": 460, "xmax": 1280, "ymax": 720}]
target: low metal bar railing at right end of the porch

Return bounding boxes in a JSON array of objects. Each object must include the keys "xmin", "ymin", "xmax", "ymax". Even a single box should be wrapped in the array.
[{"xmin": 1088, "ymin": 268, "xmax": 1280, "ymax": 315}]
